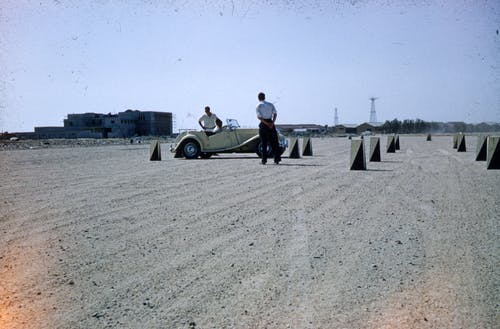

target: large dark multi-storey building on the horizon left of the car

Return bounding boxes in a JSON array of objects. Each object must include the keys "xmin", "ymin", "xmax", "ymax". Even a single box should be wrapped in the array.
[{"xmin": 29, "ymin": 110, "xmax": 172, "ymax": 138}]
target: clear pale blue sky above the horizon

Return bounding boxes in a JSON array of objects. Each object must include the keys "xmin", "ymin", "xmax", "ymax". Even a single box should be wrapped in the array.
[{"xmin": 0, "ymin": 0, "xmax": 500, "ymax": 131}]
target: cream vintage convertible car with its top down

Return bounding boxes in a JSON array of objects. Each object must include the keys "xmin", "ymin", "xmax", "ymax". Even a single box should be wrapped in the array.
[{"xmin": 170, "ymin": 119, "xmax": 288, "ymax": 159}]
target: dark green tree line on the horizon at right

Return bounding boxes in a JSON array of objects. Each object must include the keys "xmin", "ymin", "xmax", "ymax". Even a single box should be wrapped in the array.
[{"xmin": 381, "ymin": 119, "xmax": 500, "ymax": 134}]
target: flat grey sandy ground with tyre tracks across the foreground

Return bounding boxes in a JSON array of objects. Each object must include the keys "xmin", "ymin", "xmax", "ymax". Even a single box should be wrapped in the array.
[{"xmin": 0, "ymin": 136, "xmax": 500, "ymax": 329}]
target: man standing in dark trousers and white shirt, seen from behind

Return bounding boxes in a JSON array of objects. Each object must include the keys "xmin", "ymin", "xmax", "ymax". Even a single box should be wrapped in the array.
[{"xmin": 256, "ymin": 93, "xmax": 281, "ymax": 164}]
